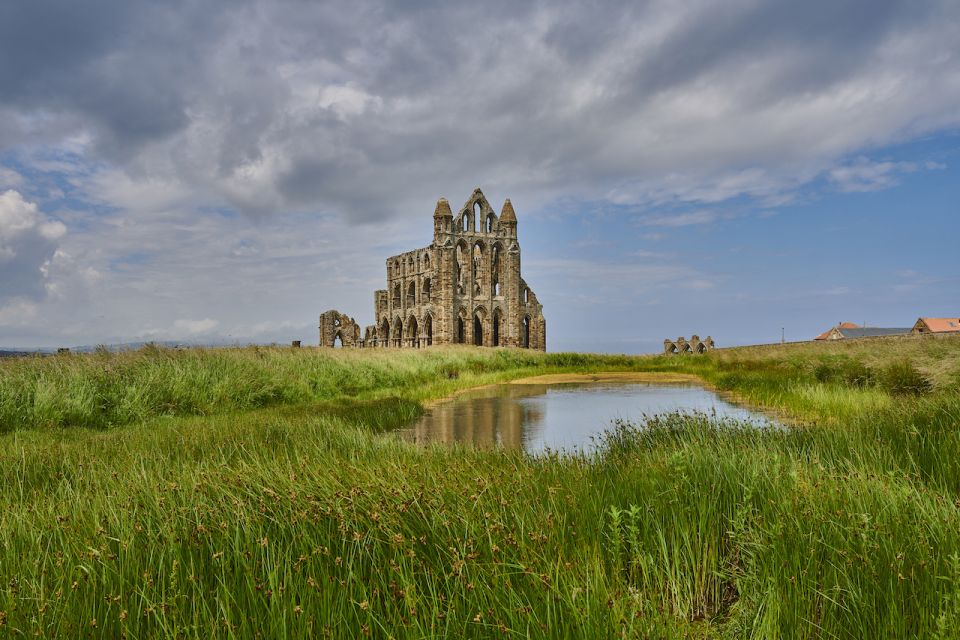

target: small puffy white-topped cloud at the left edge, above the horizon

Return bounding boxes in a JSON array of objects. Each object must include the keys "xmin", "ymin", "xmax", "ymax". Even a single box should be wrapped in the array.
[{"xmin": 0, "ymin": 189, "xmax": 67, "ymax": 304}]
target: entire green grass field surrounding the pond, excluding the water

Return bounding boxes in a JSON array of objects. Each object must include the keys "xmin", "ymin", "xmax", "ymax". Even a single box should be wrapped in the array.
[{"xmin": 0, "ymin": 339, "xmax": 960, "ymax": 638}]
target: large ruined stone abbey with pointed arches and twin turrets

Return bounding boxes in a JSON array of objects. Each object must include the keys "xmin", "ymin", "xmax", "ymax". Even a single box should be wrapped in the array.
[{"xmin": 320, "ymin": 187, "xmax": 547, "ymax": 350}]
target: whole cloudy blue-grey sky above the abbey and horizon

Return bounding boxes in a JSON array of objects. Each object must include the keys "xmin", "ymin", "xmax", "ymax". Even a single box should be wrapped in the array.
[{"xmin": 0, "ymin": 0, "xmax": 960, "ymax": 353}]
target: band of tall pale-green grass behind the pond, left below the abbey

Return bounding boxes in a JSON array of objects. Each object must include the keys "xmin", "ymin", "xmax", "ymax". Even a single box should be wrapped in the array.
[{"xmin": 0, "ymin": 346, "xmax": 636, "ymax": 432}]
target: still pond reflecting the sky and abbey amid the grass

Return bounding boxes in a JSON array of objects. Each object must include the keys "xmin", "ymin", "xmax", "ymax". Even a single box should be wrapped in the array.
[{"xmin": 400, "ymin": 382, "xmax": 773, "ymax": 452}]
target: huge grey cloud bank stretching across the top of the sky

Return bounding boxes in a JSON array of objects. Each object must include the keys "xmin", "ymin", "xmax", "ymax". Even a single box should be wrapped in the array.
[{"xmin": 0, "ymin": 0, "xmax": 960, "ymax": 224}]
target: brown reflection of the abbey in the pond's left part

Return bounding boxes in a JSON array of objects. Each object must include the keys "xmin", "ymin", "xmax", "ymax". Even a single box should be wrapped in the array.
[{"xmin": 407, "ymin": 384, "xmax": 548, "ymax": 449}]
